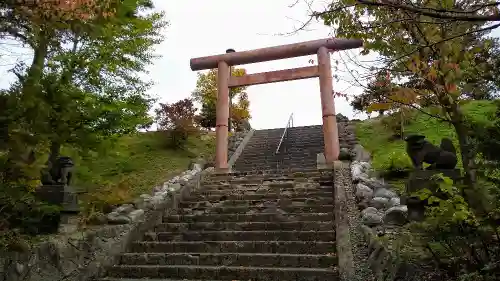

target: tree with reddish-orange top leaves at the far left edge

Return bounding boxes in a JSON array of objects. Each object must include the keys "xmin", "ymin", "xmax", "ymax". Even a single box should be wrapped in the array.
[{"xmin": 0, "ymin": 0, "xmax": 118, "ymax": 184}]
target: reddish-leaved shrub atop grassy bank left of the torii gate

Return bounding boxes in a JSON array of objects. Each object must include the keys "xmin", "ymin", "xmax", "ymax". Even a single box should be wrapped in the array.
[{"xmin": 156, "ymin": 99, "xmax": 197, "ymax": 148}]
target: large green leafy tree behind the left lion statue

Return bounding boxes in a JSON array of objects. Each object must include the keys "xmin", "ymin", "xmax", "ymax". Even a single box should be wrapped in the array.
[{"xmin": 2, "ymin": 0, "xmax": 165, "ymax": 183}]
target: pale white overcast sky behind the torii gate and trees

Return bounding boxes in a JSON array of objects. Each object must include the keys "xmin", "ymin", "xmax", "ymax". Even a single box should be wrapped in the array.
[{"xmin": 0, "ymin": 0, "xmax": 498, "ymax": 129}]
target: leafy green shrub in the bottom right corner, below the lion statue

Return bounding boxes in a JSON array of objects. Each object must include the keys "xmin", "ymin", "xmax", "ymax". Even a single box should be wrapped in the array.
[{"xmin": 399, "ymin": 175, "xmax": 500, "ymax": 281}]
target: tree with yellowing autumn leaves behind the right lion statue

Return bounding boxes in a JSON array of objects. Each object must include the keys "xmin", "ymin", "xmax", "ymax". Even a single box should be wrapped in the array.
[{"xmin": 321, "ymin": 1, "xmax": 495, "ymax": 186}]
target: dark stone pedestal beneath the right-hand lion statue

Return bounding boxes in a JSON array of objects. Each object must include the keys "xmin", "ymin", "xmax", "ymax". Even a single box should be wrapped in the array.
[{"xmin": 402, "ymin": 169, "xmax": 462, "ymax": 221}]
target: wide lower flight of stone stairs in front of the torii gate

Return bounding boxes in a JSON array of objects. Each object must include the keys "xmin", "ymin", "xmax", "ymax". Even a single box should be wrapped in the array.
[{"xmin": 99, "ymin": 167, "xmax": 339, "ymax": 281}]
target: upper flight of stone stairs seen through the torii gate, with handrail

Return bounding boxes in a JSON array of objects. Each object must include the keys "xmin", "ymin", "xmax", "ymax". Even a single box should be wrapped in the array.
[{"xmin": 233, "ymin": 122, "xmax": 356, "ymax": 172}]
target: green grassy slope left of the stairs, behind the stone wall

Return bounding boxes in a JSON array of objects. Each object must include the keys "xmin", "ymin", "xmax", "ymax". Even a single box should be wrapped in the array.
[{"xmin": 65, "ymin": 132, "xmax": 215, "ymax": 195}]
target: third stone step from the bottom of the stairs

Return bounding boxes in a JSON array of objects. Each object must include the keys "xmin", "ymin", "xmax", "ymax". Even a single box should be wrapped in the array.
[{"xmin": 129, "ymin": 240, "xmax": 336, "ymax": 254}]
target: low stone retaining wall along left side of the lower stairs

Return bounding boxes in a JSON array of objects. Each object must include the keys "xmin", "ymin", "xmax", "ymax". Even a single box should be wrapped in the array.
[{"xmin": 0, "ymin": 164, "xmax": 213, "ymax": 281}]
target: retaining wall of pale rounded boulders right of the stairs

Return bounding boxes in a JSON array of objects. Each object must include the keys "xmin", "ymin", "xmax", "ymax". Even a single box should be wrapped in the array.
[{"xmin": 351, "ymin": 145, "xmax": 422, "ymax": 281}]
